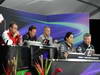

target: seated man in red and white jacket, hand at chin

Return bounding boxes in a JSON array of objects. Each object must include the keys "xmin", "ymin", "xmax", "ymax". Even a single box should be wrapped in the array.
[{"xmin": 2, "ymin": 23, "xmax": 22, "ymax": 45}]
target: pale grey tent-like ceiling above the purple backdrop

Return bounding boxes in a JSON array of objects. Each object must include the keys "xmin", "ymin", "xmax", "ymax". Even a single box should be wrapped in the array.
[{"xmin": 1, "ymin": 0, "xmax": 100, "ymax": 19}]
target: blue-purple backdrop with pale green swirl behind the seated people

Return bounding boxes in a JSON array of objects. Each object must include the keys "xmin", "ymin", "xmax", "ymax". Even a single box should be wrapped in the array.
[{"xmin": 0, "ymin": 7, "xmax": 89, "ymax": 44}]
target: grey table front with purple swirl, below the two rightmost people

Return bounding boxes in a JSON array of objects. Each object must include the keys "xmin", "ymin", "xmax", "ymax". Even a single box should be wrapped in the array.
[{"xmin": 49, "ymin": 59, "xmax": 100, "ymax": 75}]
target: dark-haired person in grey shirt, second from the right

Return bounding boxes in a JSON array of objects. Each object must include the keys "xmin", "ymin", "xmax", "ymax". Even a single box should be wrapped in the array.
[{"xmin": 59, "ymin": 32, "xmax": 75, "ymax": 58}]
